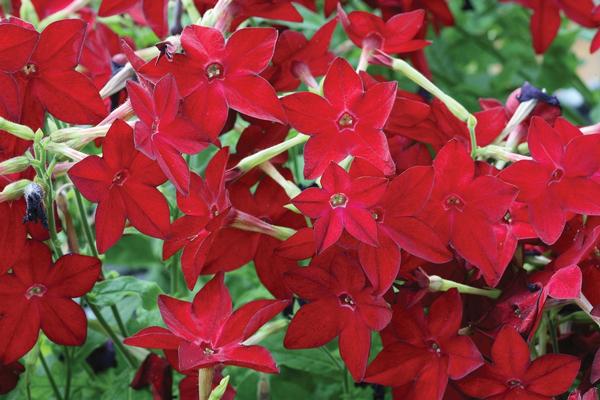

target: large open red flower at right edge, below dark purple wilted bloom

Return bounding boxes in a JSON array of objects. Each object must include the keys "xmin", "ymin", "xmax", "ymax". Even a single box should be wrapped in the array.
[{"xmin": 498, "ymin": 117, "xmax": 600, "ymax": 244}]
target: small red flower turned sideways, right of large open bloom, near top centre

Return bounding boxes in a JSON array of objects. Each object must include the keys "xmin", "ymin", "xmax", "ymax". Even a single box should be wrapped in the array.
[{"xmin": 263, "ymin": 19, "xmax": 337, "ymax": 91}]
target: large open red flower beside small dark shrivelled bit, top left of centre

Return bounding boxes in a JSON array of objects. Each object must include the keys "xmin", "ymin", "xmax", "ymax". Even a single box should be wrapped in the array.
[{"xmin": 139, "ymin": 25, "xmax": 286, "ymax": 138}]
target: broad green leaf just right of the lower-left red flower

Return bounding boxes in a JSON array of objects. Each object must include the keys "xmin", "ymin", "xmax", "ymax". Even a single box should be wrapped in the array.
[{"xmin": 88, "ymin": 276, "xmax": 162, "ymax": 310}]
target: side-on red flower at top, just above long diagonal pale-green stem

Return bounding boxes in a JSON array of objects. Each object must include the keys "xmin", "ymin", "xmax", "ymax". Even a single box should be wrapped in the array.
[{"xmin": 338, "ymin": 5, "xmax": 430, "ymax": 54}]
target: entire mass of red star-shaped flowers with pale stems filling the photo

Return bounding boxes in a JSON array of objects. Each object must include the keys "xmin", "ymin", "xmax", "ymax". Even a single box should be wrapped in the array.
[{"xmin": 0, "ymin": 0, "xmax": 600, "ymax": 400}]
